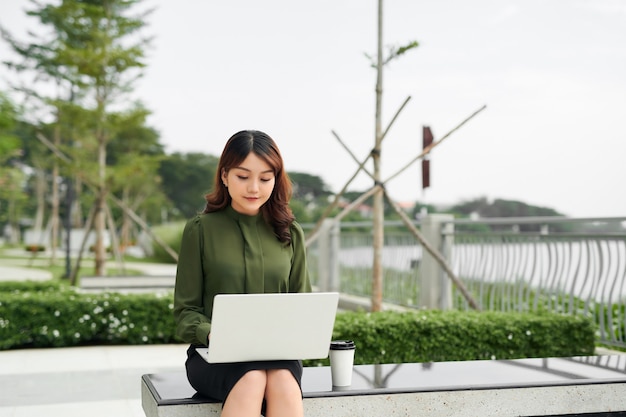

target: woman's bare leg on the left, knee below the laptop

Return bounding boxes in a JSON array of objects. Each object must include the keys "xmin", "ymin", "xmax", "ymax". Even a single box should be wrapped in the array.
[{"xmin": 221, "ymin": 370, "xmax": 264, "ymax": 417}]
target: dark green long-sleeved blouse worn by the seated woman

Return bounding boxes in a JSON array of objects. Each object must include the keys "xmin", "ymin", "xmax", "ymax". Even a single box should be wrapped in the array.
[{"xmin": 174, "ymin": 206, "xmax": 311, "ymax": 345}]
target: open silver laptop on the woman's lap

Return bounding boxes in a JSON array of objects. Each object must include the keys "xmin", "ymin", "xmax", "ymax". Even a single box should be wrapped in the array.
[{"xmin": 197, "ymin": 292, "xmax": 339, "ymax": 363}]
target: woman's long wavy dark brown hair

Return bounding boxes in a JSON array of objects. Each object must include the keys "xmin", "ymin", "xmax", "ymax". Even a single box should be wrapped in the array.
[{"xmin": 203, "ymin": 130, "xmax": 294, "ymax": 243}]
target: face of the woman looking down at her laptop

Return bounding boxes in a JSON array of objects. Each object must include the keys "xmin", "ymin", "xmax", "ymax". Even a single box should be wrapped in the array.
[{"xmin": 222, "ymin": 152, "xmax": 276, "ymax": 216}]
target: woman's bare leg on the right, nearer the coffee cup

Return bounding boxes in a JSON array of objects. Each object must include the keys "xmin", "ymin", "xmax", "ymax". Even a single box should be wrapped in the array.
[{"xmin": 265, "ymin": 369, "xmax": 304, "ymax": 417}]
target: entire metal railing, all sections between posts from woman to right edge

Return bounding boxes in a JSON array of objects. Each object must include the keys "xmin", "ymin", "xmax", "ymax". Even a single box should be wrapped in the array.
[{"xmin": 309, "ymin": 217, "xmax": 626, "ymax": 347}]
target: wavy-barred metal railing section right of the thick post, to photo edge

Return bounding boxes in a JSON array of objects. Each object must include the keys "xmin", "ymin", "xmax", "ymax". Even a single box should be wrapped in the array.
[{"xmin": 448, "ymin": 217, "xmax": 626, "ymax": 347}]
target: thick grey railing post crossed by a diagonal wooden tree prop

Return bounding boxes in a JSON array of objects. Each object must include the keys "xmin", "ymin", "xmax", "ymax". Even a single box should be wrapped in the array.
[{"xmin": 420, "ymin": 214, "xmax": 454, "ymax": 310}]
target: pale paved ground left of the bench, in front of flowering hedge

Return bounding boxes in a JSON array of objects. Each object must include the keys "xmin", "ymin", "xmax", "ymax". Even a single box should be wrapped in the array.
[{"xmin": 0, "ymin": 344, "xmax": 187, "ymax": 417}]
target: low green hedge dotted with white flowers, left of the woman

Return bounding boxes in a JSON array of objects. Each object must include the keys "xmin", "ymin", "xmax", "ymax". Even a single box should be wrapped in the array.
[{"xmin": 0, "ymin": 283, "xmax": 177, "ymax": 349}]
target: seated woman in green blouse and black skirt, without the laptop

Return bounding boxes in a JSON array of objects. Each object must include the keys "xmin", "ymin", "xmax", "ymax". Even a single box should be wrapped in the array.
[{"xmin": 174, "ymin": 131, "xmax": 311, "ymax": 417}]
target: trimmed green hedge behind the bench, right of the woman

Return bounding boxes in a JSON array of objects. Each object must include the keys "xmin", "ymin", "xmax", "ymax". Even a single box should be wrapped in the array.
[{"xmin": 308, "ymin": 310, "xmax": 595, "ymax": 365}]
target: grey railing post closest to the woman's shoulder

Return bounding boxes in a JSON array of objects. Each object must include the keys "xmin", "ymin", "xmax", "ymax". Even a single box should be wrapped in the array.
[{"xmin": 317, "ymin": 219, "xmax": 339, "ymax": 291}]
